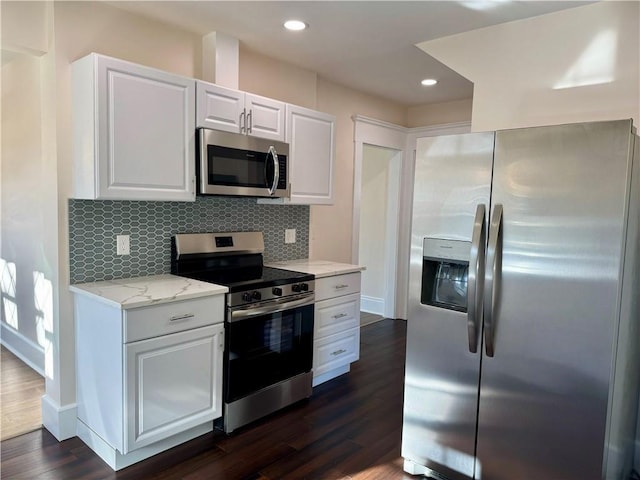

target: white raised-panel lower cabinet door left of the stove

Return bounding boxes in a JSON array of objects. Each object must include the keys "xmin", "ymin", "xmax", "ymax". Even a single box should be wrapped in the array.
[{"xmin": 122, "ymin": 324, "xmax": 224, "ymax": 454}]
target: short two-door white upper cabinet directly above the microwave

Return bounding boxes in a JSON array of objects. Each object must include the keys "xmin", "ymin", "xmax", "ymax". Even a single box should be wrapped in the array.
[{"xmin": 196, "ymin": 81, "xmax": 285, "ymax": 142}]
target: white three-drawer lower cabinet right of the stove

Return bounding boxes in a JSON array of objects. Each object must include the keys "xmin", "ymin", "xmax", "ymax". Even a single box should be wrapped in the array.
[{"xmin": 313, "ymin": 273, "xmax": 360, "ymax": 386}]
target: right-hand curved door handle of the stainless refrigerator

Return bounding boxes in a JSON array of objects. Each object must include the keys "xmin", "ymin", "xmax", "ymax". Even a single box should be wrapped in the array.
[{"xmin": 484, "ymin": 204, "xmax": 502, "ymax": 357}]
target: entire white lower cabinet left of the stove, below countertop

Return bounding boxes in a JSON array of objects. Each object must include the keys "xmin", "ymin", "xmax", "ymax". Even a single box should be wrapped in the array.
[{"xmin": 74, "ymin": 295, "xmax": 224, "ymax": 470}]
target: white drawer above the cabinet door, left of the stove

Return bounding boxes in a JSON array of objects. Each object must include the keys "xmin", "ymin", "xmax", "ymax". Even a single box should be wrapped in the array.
[{"xmin": 124, "ymin": 295, "xmax": 225, "ymax": 343}]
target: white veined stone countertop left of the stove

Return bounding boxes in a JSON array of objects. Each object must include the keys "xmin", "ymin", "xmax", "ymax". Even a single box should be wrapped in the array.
[{"xmin": 69, "ymin": 274, "xmax": 229, "ymax": 309}]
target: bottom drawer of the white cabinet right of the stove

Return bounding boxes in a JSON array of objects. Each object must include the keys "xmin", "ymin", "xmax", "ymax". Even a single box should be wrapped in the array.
[{"xmin": 313, "ymin": 327, "xmax": 360, "ymax": 376}]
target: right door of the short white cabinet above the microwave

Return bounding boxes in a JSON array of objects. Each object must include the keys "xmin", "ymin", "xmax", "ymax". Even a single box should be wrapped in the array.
[{"xmin": 245, "ymin": 93, "xmax": 285, "ymax": 142}]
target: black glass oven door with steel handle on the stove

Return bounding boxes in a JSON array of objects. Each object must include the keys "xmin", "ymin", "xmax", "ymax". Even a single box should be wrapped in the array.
[{"xmin": 224, "ymin": 294, "xmax": 314, "ymax": 403}]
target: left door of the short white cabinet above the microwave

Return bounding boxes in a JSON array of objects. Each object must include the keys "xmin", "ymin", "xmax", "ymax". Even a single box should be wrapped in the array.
[{"xmin": 196, "ymin": 81, "xmax": 246, "ymax": 133}]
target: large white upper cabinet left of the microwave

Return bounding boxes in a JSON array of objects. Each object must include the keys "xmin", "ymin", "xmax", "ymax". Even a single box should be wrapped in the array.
[{"xmin": 72, "ymin": 53, "xmax": 196, "ymax": 201}]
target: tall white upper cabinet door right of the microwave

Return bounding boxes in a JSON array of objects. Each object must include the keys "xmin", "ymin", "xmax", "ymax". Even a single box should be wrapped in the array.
[{"xmin": 286, "ymin": 105, "xmax": 336, "ymax": 205}]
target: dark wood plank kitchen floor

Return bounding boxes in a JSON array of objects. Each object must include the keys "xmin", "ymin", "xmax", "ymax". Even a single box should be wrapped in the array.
[{"xmin": 1, "ymin": 319, "xmax": 413, "ymax": 480}]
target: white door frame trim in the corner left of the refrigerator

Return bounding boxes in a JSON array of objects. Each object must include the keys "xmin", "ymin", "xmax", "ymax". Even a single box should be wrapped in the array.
[{"xmin": 351, "ymin": 115, "xmax": 471, "ymax": 318}]
